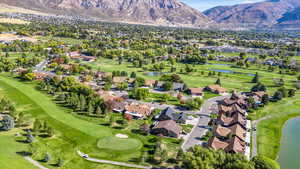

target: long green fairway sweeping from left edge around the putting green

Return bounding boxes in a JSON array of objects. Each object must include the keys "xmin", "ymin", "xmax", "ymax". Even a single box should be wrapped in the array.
[{"xmin": 0, "ymin": 76, "xmax": 142, "ymax": 168}]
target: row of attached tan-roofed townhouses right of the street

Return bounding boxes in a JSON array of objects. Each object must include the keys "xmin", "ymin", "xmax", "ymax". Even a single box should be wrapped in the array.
[{"xmin": 208, "ymin": 92, "xmax": 247, "ymax": 154}]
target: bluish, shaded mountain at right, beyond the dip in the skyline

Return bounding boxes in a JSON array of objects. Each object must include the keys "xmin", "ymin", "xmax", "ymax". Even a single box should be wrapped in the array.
[{"xmin": 204, "ymin": 0, "xmax": 300, "ymax": 28}]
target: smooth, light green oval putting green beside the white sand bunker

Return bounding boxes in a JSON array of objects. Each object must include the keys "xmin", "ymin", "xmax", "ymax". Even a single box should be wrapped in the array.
[{"xmin": 97, "ymin": 136, "xmax": 142, "ymax": 151}]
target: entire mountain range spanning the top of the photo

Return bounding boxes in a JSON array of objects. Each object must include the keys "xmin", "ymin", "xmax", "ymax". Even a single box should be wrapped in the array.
[{"xmin": 0, "ymin": 0, "xmax": 300, "ymax": 29}]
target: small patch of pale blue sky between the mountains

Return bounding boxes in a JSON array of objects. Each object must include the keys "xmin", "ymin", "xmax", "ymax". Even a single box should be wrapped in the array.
[{"xmin": 180, "ymin": 0, "xmax": 263, "ymax": 11}]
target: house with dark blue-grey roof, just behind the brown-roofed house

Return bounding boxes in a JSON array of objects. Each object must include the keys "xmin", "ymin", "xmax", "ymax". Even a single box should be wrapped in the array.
[{"xmin": 157, "ymin": 107, "xmax": 187, "ymax": 124}]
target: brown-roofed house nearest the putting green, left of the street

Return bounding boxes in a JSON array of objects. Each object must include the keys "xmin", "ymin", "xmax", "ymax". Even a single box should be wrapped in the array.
[{"xmin": 151, "ymin": 120, "xmax": 182, "ymax": 138}]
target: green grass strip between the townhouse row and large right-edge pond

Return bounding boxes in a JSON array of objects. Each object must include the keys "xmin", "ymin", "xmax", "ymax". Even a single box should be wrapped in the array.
[{"xmin": 257, "ymin": 95, "xmax": 300, "ymax": 159}]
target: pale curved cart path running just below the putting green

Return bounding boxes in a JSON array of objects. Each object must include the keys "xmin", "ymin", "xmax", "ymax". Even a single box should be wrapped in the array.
[{"xmin": 77, "ymin": 151, "xmax": 152, "ymax": 169}]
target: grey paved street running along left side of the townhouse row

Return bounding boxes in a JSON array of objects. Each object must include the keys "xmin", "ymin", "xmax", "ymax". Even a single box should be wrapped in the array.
[{"xmin": 182, "ymin": 96, "xmax": 229, "ymax": 151}]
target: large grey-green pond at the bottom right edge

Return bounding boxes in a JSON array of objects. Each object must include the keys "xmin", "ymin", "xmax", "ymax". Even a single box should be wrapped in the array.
[{"xmin": 278, "ymin": 117, "xmax": 300, "ymax": 169}]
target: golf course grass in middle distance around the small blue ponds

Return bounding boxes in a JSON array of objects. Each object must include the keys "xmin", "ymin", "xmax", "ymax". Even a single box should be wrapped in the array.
[{"xmin": 87, "ymin": 58, "xmax": 296, "ymax": 94}]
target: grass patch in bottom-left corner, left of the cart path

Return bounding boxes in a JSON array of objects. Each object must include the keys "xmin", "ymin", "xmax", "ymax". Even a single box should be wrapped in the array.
[{"xmin": 0, "ymin": 130, "xmax": 37, "ymax": 169}]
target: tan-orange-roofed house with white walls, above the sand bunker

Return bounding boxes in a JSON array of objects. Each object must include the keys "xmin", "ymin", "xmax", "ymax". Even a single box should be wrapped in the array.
[{"xmin": 125, "ymin": 104, "xmax": 153, "ymax": 118}]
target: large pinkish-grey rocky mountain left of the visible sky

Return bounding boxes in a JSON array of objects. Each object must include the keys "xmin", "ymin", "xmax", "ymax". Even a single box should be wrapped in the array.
[{"xmin": 0, "ymin": 0, "xmax": 212, "ymax": 27}]
